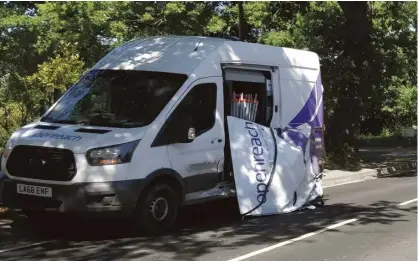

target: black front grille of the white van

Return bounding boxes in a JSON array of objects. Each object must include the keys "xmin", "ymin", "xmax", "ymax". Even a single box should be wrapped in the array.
[{"xmin": 6, "ymin": 146, "xmax": 77, "ymax": 181}]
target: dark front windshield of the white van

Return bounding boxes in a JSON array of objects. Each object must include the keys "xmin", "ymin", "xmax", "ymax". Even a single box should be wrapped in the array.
[{"xmin": 41, "ymin": 70, "xmax": 187, "ymax": 128}]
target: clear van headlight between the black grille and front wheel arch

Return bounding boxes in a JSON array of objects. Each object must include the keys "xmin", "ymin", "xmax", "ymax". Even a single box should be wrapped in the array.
[{"xmin": 86, "ymin": 140, "xmax": 140, "ymax": 166}]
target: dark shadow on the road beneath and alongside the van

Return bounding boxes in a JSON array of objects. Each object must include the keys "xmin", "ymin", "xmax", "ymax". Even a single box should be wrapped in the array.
[{"xmin": 0, "ymin": 194, "xmax": 417, "ymax": 261}]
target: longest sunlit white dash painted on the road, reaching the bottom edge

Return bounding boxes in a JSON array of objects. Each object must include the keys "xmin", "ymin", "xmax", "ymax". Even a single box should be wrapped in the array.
[{"xmin": 228, "ymin": 218, "xmax": 358, "ymax": 261}]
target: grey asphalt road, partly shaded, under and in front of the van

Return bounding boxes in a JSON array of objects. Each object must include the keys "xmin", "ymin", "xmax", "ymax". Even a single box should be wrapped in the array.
[{"xmin": 0, "ymin": 172, "xmax": 417, "ymax": 261}]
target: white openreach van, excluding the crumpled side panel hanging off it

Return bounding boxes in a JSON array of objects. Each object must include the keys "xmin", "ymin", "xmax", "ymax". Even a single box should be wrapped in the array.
[{"xmin": 1, "ymin": 36, "xmax": 323, "ymax": 233}]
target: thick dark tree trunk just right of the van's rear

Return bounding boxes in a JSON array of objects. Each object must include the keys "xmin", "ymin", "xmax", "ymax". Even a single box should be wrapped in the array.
[{"xmin": 329, "ymin": 1, "xmax": 373, "ymax": 153}]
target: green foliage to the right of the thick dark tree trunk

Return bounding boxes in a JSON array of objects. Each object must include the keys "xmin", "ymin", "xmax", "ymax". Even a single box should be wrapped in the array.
[{"xmin": 363, "ymin": 2, "xmax": 417, "ymax": 135}]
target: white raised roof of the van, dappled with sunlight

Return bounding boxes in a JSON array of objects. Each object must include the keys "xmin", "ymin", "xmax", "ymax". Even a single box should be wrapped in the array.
[{"xmin": 92, "ymin": 36, "xmax": 319, "ymax": 74}]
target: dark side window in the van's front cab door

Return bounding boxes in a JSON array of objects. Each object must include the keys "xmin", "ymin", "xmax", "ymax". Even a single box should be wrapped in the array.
[{"xmin": 153, "ymin": 83, "xmax": 217, "ymax": 146}]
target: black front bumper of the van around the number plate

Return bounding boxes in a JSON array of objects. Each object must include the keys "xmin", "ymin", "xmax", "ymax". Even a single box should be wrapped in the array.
[{"xmin": 0, "ymin": 179, "xmax": 143, "ymax": 216}]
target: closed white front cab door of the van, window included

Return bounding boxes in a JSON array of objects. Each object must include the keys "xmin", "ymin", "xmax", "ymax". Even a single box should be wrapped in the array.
[{"xmin": 163, "ymin": 77, "xmax": 225, "ymax": 194}]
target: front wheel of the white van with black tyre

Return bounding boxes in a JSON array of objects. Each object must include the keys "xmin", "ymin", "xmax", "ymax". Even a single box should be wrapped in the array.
[{"xmin": 133, "ymin": 184, "xmax": 180, "ymax": 235}]
